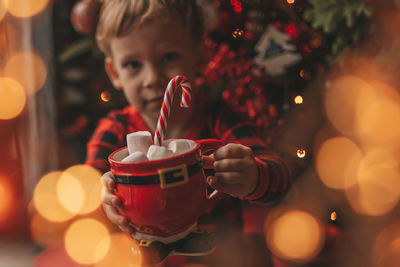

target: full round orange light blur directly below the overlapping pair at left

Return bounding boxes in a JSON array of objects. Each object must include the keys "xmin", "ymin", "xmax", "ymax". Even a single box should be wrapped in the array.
[{"xmin": 64, "ymin": 219, "xmax": 111, "ymax": 264}]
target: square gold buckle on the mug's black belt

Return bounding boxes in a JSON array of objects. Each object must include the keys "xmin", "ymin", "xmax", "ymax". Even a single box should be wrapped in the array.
[{"xmin": 158, "ymin": 164, "xmax": 189, "ymax": 189}]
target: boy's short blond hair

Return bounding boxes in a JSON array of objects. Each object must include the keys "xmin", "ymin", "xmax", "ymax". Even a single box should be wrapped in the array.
[{"xmin": 96, "ymin": 0, "xmax": 203, "ymax": 56}]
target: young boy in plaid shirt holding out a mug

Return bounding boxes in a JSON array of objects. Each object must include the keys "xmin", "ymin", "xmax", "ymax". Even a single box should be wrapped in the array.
[{"xmin": 86, "ymin": 0, "xmax": 291, "ymax": 266}]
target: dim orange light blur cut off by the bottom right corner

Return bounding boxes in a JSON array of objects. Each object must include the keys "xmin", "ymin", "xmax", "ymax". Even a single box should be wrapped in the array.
[{"xmin": 371, "ymin": 222, "xmax": 400, "ymax": 267}]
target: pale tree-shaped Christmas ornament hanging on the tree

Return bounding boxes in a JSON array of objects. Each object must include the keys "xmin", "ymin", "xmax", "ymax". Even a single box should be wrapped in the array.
[{"xmin": 254, "ymin": 25, "xmax": 301, "ymax": 76}]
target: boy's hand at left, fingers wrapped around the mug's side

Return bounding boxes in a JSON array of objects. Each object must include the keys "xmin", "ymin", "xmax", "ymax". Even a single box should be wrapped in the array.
[{"xmin": 101, "ymin": 172, "xmax": 134, "ymax": 234}]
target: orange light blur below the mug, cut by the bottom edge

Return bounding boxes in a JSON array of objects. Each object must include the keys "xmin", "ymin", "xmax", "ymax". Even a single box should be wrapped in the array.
[{"xmin": 94, "ymin": 233, "xmax": 142, "ymax": 267}]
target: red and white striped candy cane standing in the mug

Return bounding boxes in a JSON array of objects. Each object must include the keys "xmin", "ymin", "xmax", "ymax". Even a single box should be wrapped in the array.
[{"xmin": 154, "ymin": 75, "xmax": 192, "ymax": 146}]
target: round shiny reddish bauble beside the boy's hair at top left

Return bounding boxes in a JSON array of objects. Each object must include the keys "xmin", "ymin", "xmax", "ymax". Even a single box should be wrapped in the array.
[{"xmin": 71, "ymin": 0, "xmax": 100, "ymax": 35}]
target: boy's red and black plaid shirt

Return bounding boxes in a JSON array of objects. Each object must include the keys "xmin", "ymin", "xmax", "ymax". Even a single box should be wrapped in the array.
[{"xmin": 86, "ymin": 98, "xmax": 291, "ymax": 232}]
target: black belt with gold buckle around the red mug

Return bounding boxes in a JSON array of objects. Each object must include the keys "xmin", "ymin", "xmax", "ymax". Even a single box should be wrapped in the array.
[{"xmin": 114, "ymin": 161, "xmax": 203, "ymax": 188}]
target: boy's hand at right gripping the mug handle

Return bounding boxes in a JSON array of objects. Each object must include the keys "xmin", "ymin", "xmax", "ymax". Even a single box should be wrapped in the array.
[{"xmin": 207, "ymin": 144, "xmax": 259, "ymax": 197}]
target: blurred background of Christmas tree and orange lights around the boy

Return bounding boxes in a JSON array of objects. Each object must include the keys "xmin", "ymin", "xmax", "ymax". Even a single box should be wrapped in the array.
[{"xmin": 0, "ymin": 0, "xmax": 400, "ymax": 267}]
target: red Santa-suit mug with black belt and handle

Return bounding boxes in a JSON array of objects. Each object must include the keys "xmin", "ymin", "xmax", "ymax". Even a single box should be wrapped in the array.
[{"xmin": 108, "ymin": 139, "xmax": 224, "ymax": 240}]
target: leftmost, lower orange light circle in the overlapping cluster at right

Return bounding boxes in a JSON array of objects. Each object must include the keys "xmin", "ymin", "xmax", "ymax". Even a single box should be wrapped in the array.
[{"xmin": 315, "ymin": 137, "xmax": 362, "ymax": 189}]
